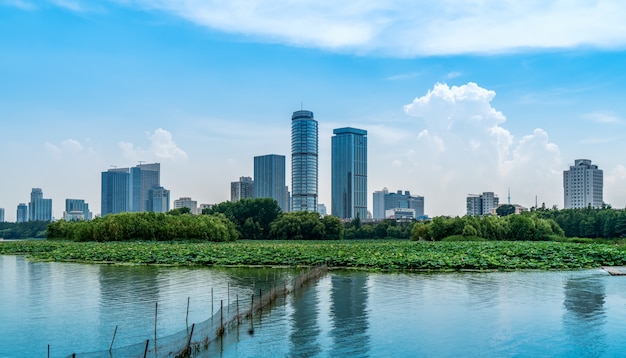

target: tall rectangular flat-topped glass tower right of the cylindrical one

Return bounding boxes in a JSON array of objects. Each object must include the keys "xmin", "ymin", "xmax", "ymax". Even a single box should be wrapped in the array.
[{"xmin": 331, "ymin": 128, "xmax": 367, "ymax": 219}]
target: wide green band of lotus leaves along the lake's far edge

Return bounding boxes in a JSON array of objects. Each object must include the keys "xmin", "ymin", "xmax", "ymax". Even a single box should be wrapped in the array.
[{"xmin": 0, "ymin": 241, "xmax": 626, "ymax": 271}]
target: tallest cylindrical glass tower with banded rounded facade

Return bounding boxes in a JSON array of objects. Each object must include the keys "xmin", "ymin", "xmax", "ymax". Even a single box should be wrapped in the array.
[{"xmin": 291, "ymin": 110, "xmax": 318, "ymax": 212}]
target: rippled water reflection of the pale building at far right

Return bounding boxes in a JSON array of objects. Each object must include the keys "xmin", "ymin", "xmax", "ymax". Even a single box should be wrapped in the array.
[{"xmin": 563, "ymin": 276, "xmax": 606, "ymax": 357}]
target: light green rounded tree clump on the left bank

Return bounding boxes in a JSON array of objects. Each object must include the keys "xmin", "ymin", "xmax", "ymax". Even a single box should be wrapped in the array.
[{"xmin": 48, "ymin": 213, "xmax": 237, "ymax": 241}]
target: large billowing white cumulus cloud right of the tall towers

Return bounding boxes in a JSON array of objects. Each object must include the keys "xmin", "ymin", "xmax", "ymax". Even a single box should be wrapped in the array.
[{"xmin": 404, "ymin": 82, "xmax": 561, "ymax": 215}]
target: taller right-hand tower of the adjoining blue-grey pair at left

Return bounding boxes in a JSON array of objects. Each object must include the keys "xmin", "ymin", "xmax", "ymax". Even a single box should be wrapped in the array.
[{"xmin": 130, "ymin": 163, "xmax": 161, "ymax": 212}]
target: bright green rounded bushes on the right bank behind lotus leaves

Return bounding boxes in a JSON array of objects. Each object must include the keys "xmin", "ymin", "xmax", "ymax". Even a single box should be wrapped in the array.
[{"xmin": 411, "ymin": 215, "xmax": 564, "ymax": 241}]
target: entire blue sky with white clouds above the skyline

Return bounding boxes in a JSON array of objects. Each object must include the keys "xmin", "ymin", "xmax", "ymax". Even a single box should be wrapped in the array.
[{"xmin": 0, "ymin": 0, "xmax": 626, "ymax": 221}]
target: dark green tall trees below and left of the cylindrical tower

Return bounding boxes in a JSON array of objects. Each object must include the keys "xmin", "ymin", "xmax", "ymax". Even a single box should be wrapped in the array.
[{"xmin": 202, "ymin": 198, "xmax": 281, "ymax": 240}]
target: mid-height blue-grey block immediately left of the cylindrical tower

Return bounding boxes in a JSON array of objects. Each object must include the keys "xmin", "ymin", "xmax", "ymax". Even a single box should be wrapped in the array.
[{"xmin": 254, "ymin": 154, "xmax": 289, "ymax": 213}]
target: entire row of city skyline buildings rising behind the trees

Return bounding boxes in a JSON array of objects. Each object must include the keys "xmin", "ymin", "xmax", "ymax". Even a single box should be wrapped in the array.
[{"xmin": 0, "ymin": 103, "xmax": 604, "ymax": 223}]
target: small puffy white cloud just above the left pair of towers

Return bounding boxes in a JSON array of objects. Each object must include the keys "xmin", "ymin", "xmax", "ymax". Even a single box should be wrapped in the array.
[{"xmin": 119, "ymin": 128, "xmax": 187, "ymax": 161}]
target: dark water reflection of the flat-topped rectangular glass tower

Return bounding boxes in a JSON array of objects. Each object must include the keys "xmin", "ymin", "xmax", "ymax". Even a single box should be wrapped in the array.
[{"xmin": 329, "ymin": 273, "xmax": 370, "ymax": 357}]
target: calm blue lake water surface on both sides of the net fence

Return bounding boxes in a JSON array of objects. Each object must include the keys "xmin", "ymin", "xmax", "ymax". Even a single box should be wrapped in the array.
[{"xmin": 0, "ymin": 256, "xmax": 626, "ymax": 357}]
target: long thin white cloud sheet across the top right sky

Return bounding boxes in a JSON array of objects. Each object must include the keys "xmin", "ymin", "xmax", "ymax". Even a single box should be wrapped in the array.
[{"xmin": 123, "ymin": 0, "xmax": 626, "ymax": 57}]
